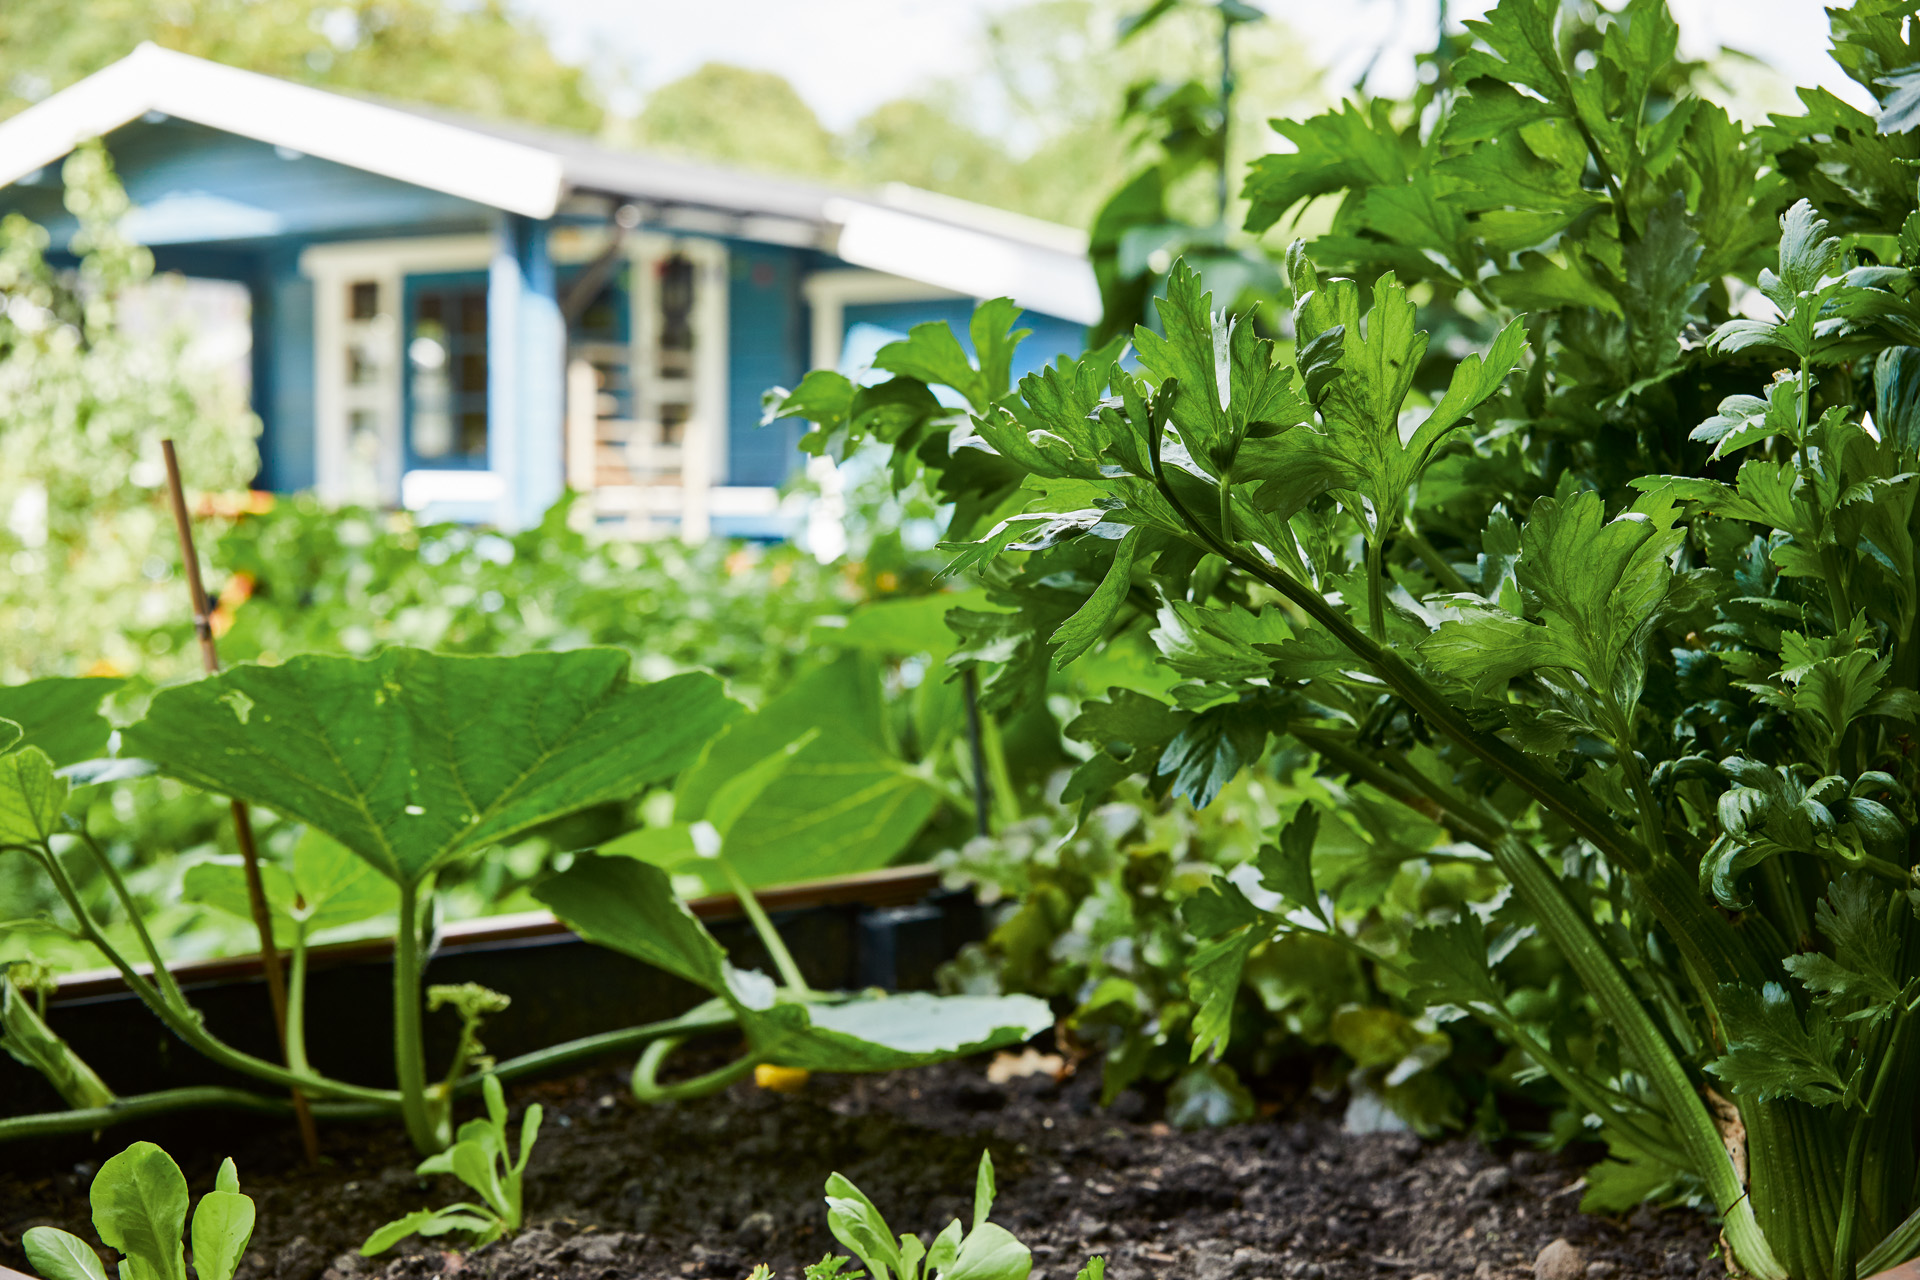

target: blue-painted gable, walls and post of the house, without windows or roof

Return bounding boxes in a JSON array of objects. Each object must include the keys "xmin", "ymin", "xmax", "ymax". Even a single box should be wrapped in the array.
[{"xmin": 0, "ymin": 117, "xmax": 1085, "ymax": 520}]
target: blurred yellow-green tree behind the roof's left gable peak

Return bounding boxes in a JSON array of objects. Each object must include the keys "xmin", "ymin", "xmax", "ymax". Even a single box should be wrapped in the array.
[{"xmin": 0, "ymin": 0, "xmax": 605, "ymax": 132}]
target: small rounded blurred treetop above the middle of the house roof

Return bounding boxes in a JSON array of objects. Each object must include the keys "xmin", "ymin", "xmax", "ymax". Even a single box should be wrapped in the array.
[{"xmin": 626, "ymin": 61, "xmax": 845, "ymax": 178}]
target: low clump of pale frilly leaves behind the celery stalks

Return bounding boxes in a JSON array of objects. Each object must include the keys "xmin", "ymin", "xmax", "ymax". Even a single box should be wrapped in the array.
[{"xmin": 937, "ymin": 754, "xmax": 1482, "ymax": 1132}]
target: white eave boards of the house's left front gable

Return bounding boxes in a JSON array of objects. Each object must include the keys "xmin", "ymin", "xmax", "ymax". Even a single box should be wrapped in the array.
[{"xmin": 0, "ymin": 44, "xmax": 566, "ymax": 219}]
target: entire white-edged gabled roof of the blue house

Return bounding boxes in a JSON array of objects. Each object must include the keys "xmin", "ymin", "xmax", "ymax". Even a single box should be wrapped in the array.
[{"xmin": 0, "ymin": 44, "xmax": 1100, "ymax": 324}]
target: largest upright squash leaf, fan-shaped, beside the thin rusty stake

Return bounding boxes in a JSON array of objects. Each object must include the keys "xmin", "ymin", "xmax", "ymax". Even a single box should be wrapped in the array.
[{"xmin": 123, "ymin": 649, "xmax": 739, "ymax": 885}]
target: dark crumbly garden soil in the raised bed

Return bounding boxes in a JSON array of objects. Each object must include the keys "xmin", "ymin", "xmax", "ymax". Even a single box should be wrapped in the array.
[{"xmin": 0, "ymin": 1063, "xmax": 1726, "ymax": 1280}]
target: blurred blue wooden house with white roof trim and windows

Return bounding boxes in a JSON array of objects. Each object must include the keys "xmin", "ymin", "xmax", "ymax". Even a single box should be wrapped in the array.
[{"xmin": 0, "ymin": 46, "xmax": 1098, "ymax": 537}]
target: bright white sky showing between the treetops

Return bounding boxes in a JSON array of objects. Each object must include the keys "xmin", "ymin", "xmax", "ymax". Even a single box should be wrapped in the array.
[{"xmin": 522, "ymin": 0, "xmax": 1872, "ymax": 129}]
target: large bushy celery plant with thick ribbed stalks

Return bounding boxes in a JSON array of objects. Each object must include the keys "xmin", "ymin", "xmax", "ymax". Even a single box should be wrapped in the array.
[{"xmin": 764, "ymin": 0, "xmax": 1920, "ymax": 1258}]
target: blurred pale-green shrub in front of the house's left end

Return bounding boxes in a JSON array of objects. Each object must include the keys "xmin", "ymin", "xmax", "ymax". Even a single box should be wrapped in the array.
[{"xmin": 0, "ymin": 142, "xmax": 259, "ymax": 683}]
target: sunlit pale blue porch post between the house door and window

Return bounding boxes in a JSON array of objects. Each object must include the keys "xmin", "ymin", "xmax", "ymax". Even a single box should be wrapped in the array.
[{"xmin": 486, "ymin": 213, "xmax": 566, "ymax": 530}]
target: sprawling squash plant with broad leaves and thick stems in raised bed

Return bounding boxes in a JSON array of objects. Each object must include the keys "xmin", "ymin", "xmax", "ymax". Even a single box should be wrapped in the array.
[{"xmin": 0, "ymin": 649, "xmax": 1050, "ymax": 1155}]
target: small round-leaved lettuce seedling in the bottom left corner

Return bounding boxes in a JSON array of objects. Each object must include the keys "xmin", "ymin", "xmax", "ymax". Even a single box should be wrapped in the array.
[{"xmin": 21, "ymin": 1142, "xmax": 253, "ymax": 1280}]
